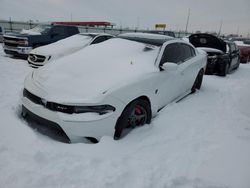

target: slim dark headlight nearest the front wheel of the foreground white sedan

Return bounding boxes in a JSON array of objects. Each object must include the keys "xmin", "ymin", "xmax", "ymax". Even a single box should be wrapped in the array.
[{"xmin": 74, "ymin": 105, "xmax": 115, "ymax": 115}]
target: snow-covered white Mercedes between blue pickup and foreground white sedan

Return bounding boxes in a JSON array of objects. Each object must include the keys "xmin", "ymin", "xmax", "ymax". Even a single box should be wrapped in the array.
[{"xmin": 28, "ymin": 33, "xmax": 113, "ymax": 67}]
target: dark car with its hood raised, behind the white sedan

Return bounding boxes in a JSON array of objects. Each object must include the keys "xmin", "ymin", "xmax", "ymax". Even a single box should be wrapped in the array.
[{"xmin": 189, "ymin": 33, "xmax": 240, "ymax": 76}]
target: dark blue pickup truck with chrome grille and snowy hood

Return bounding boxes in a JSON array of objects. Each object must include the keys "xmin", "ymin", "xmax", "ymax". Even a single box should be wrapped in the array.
[{"xmin": 3, "ymin": 25, "xmax": 79, "ymax": 57}]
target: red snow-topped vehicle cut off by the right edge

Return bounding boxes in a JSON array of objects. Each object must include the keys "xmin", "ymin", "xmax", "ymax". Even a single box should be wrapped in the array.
[{"xmin": 234, "ymin": 39, "xmax": 250, "ymax": 63}]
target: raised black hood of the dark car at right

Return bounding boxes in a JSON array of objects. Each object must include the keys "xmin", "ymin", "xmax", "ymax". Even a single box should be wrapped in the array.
[{"xmin": 189, "ymin": 33, "xmax": 227, "ymax": 53}]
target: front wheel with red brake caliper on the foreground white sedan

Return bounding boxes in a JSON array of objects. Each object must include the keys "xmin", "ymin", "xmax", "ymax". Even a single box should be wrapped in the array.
[{"xmin": 114, "ymin": 99, "xmax": 152, "ymax": 140}]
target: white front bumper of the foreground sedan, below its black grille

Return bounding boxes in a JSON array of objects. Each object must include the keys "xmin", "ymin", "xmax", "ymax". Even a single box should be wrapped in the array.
[{"xmin": 22, "ymin": 94, "xmax": 120, "ymax": 142}]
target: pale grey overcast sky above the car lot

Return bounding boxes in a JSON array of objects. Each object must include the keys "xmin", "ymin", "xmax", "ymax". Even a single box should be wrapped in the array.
[{"xmin": 0, "ymin": 0, "xmax": 250, "ymax": 36}]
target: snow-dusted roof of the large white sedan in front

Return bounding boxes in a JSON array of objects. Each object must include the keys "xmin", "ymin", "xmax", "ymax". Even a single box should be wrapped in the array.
[{"xmin": 118, "ymin": 33, "xmax": 174, "ymax": 46}]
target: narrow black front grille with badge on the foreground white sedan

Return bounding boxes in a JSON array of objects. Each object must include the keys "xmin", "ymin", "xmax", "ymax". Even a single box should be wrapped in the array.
[{"xmin": 23, "ymin": 89, "xmax": 74, "ymax": 114}]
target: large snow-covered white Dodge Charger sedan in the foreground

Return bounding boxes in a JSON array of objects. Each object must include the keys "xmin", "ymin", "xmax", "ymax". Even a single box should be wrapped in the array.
[{"xmin": 22, "ymin": 33, "xmax": 207, "ymax": 142}]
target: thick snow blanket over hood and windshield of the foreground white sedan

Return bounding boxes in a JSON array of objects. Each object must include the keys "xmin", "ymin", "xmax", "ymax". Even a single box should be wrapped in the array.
[{"xmin": 33, "ymin": 38, "xmax": 159, "ymax": 103}]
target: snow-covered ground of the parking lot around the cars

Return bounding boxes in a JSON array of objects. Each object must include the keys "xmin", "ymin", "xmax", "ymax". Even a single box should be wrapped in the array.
[{"xmin": 0, "ymin": 46, "xmax": 250, "ymax": 188}]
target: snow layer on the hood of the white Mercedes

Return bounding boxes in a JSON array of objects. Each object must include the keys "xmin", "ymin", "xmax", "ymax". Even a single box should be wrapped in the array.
[{"xmin": 30, "ymin": 34, "xmax": 92, "ymax": 58}]
